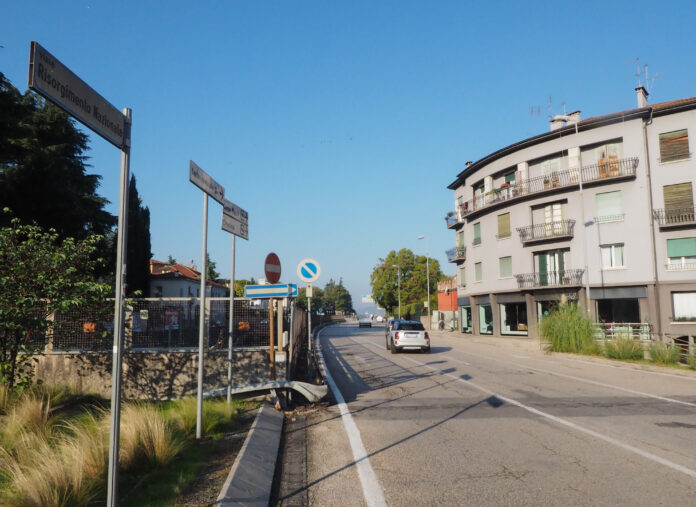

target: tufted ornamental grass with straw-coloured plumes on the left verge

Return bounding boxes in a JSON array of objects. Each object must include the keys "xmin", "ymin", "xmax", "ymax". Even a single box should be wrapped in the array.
[{"xmin": 0, "ymin": 385, "xmax": 256, "ymax": 506}]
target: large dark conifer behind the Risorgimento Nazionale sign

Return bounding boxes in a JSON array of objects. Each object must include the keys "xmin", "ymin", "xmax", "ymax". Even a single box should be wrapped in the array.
[{"xmin": 0, "ymin": 73, "xmax": 116, "ymax": 239}]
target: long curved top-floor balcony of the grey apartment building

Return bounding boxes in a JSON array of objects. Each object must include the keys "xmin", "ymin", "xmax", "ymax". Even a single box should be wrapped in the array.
[{"xmin": 460, "ymin": 157, "xmax": 638, "ymax": 220}]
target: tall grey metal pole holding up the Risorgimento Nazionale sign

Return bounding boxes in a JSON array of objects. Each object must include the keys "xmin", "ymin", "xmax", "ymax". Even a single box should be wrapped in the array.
[{"xmin": 106, "ymin": 108, "xmax": 132, "ymax": 507}]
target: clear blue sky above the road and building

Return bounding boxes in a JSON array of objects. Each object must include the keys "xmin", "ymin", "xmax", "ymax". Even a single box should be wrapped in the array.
[{"xmin": 0, "ymin": 0, "xmax": 696, "ymax": 308}]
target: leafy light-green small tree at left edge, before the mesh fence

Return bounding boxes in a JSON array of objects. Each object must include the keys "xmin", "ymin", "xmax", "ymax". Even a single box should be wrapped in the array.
[{"xmin": 0, "ymin": 214, "xmax": 111, "ymax": 388}]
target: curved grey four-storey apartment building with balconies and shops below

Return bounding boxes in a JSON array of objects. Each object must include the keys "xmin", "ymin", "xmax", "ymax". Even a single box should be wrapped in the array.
[{"xmin": 445, "ymin": 87, "xmax": 696, "ymax": 337}]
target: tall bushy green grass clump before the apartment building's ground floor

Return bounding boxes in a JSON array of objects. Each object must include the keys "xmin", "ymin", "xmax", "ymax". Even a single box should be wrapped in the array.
[{"xmin": 539, "ymin": 303, "xmax": 597, "ymax": 353}]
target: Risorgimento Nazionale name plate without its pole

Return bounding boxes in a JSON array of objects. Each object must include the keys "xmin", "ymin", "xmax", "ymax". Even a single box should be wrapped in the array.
[{"xmin": 29, "ymin": 41, "xmax": 125, "ymax": 149}]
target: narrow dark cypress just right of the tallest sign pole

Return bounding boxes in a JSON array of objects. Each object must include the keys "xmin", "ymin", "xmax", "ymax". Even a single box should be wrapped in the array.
[{"xmin": 126, "ymin": 175, "xmax": 152, "ymax": 296}]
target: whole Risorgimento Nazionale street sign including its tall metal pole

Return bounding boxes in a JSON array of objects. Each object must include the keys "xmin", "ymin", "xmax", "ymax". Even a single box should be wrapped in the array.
[{"xmin": 29, "ymin": 41, "xmax": 132, "ymax": 506}]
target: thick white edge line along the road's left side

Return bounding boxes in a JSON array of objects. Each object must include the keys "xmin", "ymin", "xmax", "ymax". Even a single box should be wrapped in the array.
[{"xmin": 317, "ymin": 329, "xmax": 387, "ymax": 507}]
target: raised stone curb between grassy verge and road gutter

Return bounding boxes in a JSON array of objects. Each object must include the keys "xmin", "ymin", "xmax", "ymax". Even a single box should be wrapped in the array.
[{"xmin": 215, "ymin": 404, "xmax": 284, "ymax": 507}]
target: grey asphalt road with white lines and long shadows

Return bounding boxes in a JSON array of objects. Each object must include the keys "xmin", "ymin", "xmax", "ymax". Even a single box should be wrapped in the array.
[{"xmin": 307, "ymin": 323, "xmax": 696, "ymax": 506}]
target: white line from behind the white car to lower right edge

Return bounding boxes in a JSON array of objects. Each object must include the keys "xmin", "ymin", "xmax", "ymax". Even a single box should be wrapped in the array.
[{"xmin": 369, "ymin": 342, "xmax": 696, "ymax": 478}]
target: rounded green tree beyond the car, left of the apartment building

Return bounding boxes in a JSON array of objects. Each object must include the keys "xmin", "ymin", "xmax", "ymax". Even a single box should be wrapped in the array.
[{"xmin": 370, "ymin": 248, "xmax": 444, "ymax": 315}]
